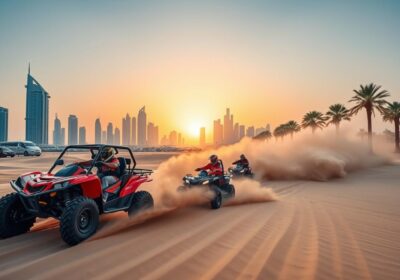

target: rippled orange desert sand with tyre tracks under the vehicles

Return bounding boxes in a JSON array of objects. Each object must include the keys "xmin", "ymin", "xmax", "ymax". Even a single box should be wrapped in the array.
[{"xmin": 0, "ymin": 149, "xmax": 400, "ymax": 279}]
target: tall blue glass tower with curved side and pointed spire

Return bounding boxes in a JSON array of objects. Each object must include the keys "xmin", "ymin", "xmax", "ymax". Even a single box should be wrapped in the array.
[{"xmin": 25, "ymin": 67, "xmax": 50, "ymax": 144}]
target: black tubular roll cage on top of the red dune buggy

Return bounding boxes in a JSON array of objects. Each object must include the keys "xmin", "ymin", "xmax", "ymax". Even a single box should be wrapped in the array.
[{"xmin": 48, "ymin": 144, "xmax": 153, "ymax": 174}]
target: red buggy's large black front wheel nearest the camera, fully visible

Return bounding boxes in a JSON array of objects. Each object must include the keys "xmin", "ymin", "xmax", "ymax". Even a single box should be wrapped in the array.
[{"xmin": 60, "ymin": 196, "xmax": 99, "ymax": 246}]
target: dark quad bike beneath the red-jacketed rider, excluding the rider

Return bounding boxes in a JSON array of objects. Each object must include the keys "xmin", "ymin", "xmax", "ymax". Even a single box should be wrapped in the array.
[{"xmin": 178, "ymin": 161, "xmax": 235, "ymax": 209}]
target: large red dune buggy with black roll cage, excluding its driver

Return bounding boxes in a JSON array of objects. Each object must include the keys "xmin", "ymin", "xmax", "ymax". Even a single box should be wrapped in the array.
[{"xmin": 0, "ymin": 145, "xmax": 154, "ymax": 246}]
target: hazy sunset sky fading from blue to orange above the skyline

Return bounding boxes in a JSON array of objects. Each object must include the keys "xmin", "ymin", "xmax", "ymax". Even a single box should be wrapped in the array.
[{"xmin": 0, "ymin": 0, "xmax": 400, "ymax": 142}]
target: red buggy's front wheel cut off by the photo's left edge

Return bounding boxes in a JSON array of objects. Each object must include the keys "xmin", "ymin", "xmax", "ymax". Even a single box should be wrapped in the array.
[{"xmin": 0, "ymin": 193, "xmax": 36, "ymax": 238}]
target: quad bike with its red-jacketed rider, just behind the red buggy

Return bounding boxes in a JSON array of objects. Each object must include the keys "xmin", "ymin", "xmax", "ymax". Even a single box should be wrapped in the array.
[{"xmin": 178, "ymin": 155, "xmax": 235, "ymax": 209}]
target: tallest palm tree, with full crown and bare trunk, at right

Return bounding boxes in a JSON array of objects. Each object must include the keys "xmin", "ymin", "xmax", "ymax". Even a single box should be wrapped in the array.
[{"xmin": 350, "ymin": 83, "xmax": 390, "ymax": 152}]
